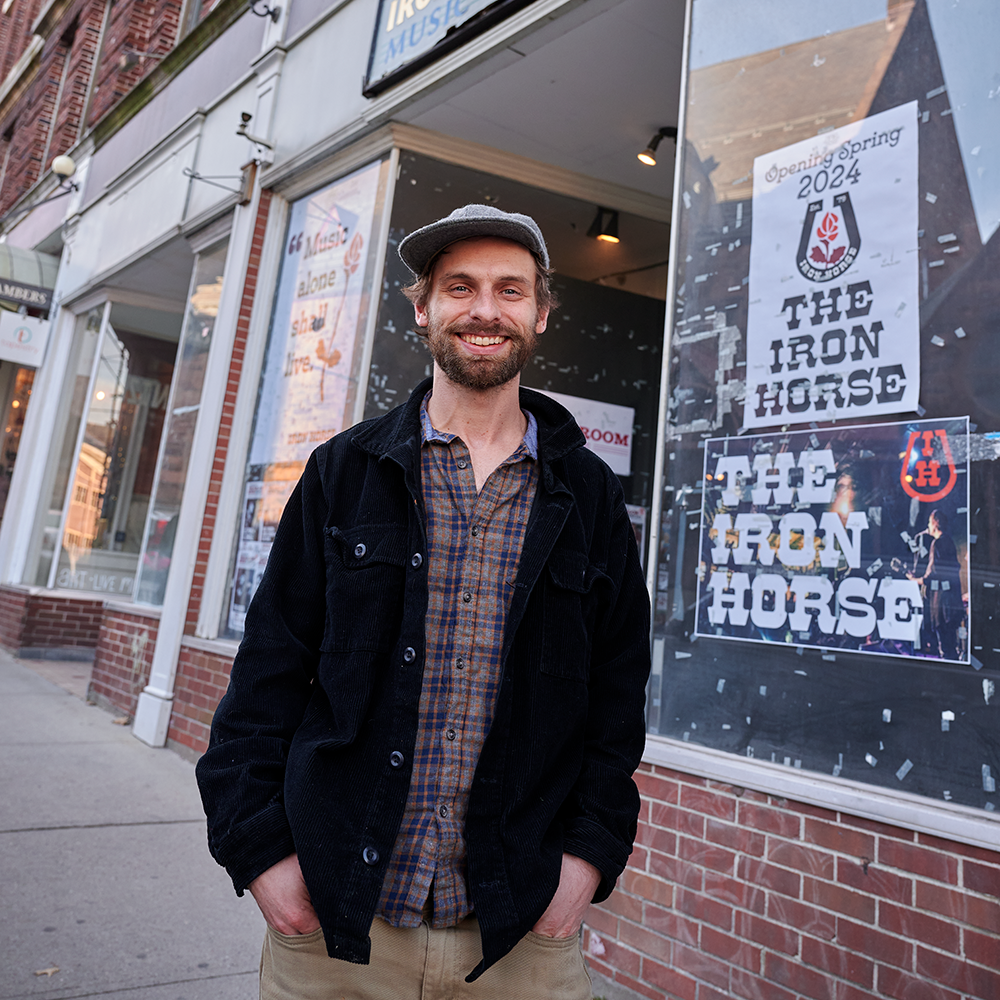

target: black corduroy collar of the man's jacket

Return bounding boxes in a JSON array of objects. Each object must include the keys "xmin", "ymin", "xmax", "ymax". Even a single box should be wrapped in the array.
[{"xmin": 354, "ymin": 378, "xmax": 586, "ymax": 478}]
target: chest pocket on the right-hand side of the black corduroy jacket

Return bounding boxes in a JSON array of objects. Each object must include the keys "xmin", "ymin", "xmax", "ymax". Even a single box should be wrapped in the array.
[{"xmin": 541, "ymin": 549, "xmax": 606, "ymax": 681}]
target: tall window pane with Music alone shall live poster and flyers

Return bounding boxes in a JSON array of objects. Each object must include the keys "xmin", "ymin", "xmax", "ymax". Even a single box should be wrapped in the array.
[{"xmin": 228, "ymin": 161, "xmax": 383, "ymax": 631}]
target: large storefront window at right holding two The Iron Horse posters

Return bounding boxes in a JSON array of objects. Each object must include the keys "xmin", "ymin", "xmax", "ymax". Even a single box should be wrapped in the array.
[{"xmin": 648, "ymin": 0, "xmax": 1000, "ymax": 810}]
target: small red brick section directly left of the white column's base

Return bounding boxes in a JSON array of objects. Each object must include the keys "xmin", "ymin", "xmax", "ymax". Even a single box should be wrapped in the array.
[{"xmin": 87, "ymin": 609, "xmax": 159, "ymax": 715}]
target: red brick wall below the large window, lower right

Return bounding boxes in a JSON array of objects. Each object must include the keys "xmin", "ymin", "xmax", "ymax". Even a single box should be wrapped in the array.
[{"xmin": 584, "ymin": 765, "xmax": 1000, "ymax": 1000}]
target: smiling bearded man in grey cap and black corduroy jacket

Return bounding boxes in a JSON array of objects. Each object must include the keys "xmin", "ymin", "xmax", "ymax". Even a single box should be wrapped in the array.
[{"xmin": 198, "ymin": 205, "xmax": 649, "ymax": 1000}]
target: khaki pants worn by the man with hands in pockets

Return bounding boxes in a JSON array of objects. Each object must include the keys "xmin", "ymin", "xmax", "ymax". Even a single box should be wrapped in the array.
[{"xmin": 260, "ymin": 917, "xmax": 593, "ymax": 1000}]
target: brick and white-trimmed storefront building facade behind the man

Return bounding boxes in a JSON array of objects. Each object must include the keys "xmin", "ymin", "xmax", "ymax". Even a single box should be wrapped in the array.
[{"xmin": 0, "ymin": 0, "xmax": 1000, "ymax": 1000}]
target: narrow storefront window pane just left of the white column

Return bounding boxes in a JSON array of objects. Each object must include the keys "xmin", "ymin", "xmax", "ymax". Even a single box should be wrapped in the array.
[{"xmin": 135, "ymin": 244, "xmax": 228, "ymax": 605}]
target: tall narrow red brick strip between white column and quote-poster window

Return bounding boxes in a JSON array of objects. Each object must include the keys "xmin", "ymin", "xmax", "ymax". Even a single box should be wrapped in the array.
[{"xmin": 184, "ymin": 191, "xmax": 271, "ymax": 635}]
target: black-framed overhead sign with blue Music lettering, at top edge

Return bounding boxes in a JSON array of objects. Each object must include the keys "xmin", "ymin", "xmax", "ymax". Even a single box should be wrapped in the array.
[{"xmin": 364, "ymin": 0, "xmax": 531, "ymax": 97}]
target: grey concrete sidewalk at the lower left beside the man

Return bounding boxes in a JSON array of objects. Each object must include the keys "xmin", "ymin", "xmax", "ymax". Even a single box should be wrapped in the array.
[{"xmin": 0, "ymin": 651, "xmax": 264, "ymax": 1000}]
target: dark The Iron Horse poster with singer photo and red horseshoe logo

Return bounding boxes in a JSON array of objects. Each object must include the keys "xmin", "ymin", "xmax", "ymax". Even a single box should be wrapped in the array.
[{"xmin": 696, "ymin": 418, "xmax": 975, "ymax": 663}]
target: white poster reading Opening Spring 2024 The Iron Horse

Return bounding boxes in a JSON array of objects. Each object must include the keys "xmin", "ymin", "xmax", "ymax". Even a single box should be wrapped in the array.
[{"xmin": 743, "ymin": 101, "xmax": 920, "ymax": 428}]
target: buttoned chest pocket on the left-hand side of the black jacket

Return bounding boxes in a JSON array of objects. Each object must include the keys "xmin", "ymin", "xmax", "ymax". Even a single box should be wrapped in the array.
[{"xmin": 320, "ymin": 524, "xmax": 409, "ymax": 652}]
